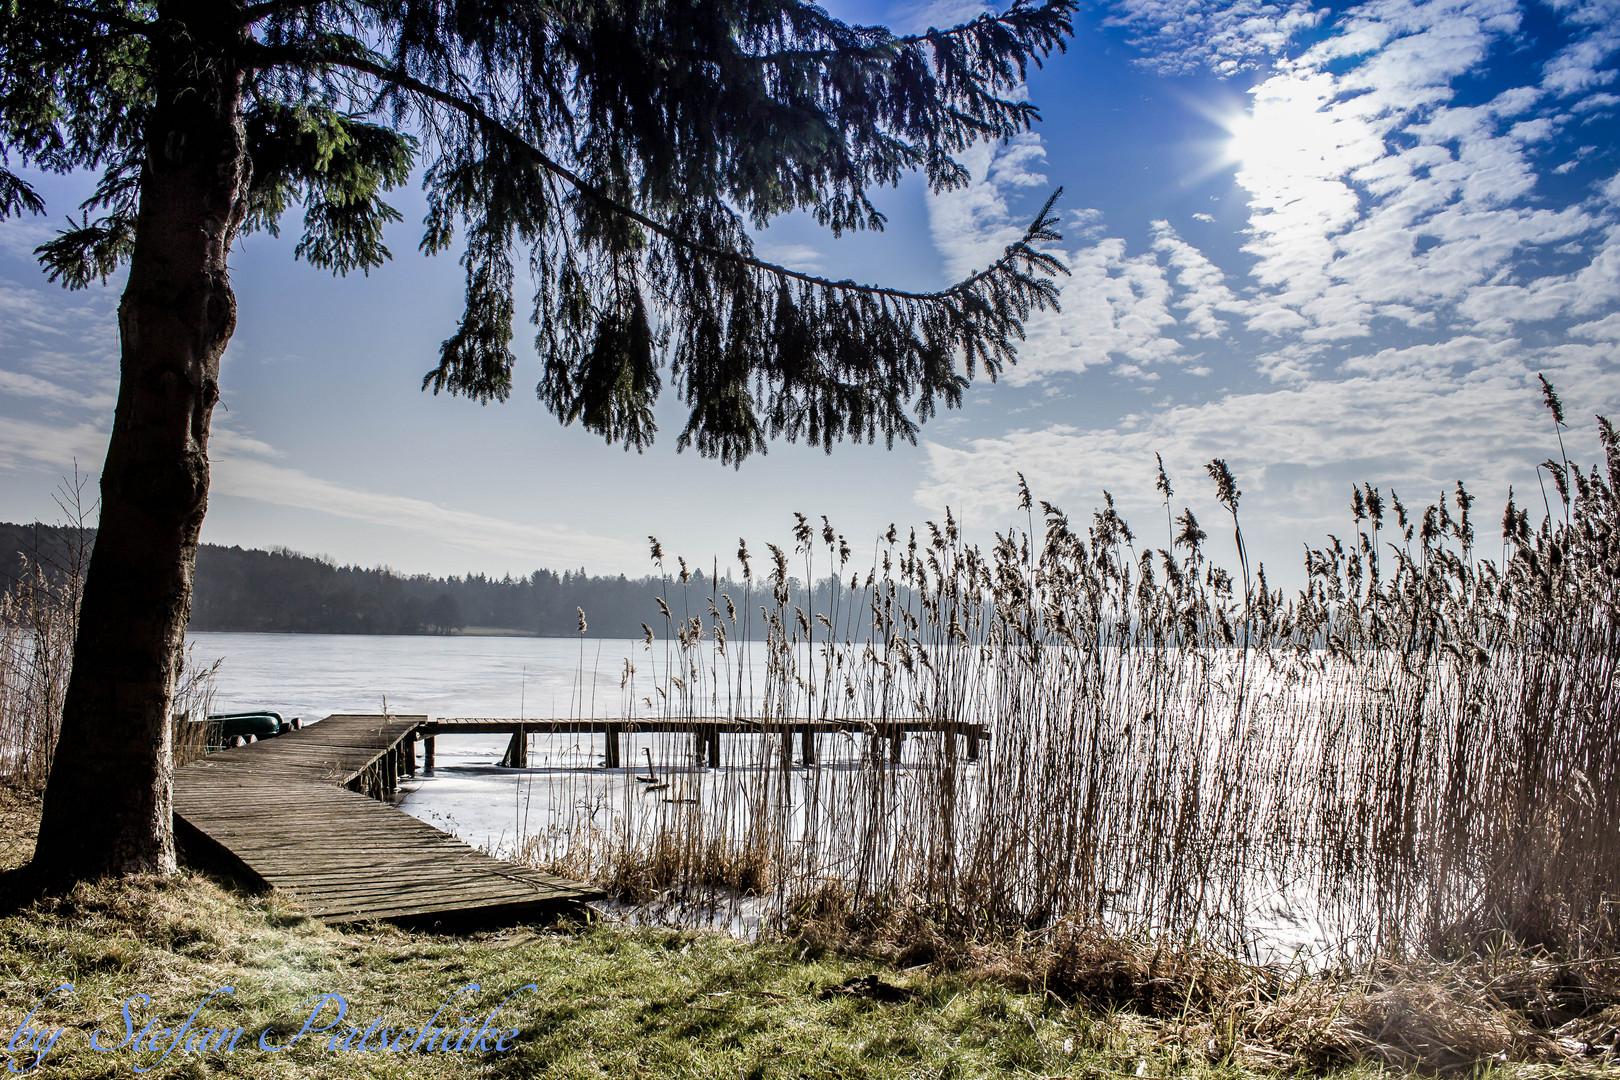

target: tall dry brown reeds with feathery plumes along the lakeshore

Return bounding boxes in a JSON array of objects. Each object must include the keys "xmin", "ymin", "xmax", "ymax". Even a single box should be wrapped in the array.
[{"xmin": 527, "ymin": 404, "xmax": 1620, "ymax": 954}]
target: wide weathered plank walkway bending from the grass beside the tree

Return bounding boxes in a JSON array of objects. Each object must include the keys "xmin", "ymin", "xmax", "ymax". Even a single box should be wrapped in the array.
[{"xmin": 175, "ymin": 716, "xmax": 601, "ymax": 925}]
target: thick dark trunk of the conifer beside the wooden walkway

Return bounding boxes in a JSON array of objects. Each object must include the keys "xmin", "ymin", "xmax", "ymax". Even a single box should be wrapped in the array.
[{"xmin": 34, "ymin": 0, "xmax": 248, "ymax": 879}]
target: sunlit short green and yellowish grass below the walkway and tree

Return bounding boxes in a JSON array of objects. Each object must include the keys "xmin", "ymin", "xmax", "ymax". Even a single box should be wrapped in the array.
[{"xmin": 0, "ymin": 793, "xmax": 1594, "ymax": 1080}]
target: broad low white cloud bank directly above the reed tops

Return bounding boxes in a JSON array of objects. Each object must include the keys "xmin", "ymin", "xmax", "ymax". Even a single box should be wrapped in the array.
[{"xmin": 917, "ymin": 346, "xmax": 1620, "ymax": 582}]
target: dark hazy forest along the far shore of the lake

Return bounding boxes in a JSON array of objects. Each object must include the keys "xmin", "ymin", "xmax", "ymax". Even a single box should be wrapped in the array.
[{"xmin": 0, "ymin": 523, "xmax": 826, "ymax": 638}]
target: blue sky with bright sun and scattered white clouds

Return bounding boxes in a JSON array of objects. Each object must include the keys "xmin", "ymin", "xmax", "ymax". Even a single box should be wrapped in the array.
[{"xmin": 0, "ymin": 0, "xmax": 1620, "ymax": 585}]
